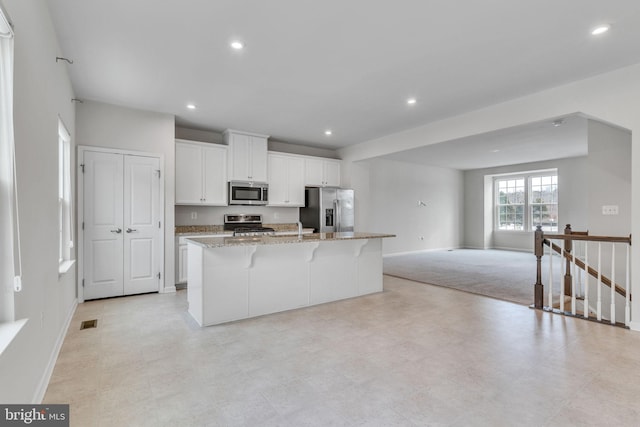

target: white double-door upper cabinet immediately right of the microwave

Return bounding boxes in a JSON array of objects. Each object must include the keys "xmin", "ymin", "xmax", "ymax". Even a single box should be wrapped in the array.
[{"xmin": 268, "ymin": 153, "xmax": 304, "ymax": 207}]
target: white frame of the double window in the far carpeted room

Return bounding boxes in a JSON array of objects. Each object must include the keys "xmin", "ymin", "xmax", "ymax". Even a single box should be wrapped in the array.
[{"xmin": 493, "ymin": 169, "xmax": 560, "ymax": 234}]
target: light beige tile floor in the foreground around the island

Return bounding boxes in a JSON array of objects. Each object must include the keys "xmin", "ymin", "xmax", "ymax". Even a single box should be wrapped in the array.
[{"xmin": 45, "ymin": 276, "xmax": 640, "ymax": 427}]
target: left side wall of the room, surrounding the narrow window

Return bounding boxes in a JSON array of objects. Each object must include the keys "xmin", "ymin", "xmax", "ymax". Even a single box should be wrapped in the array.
[{"xmin": 0, "ymin": 0, "xmax": 77, "ymax": 403}]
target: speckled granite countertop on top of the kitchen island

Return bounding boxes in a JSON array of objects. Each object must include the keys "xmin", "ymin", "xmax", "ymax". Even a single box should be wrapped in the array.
[{"xmin": 187, "ymin": 232, "xmax": 396, "ymax": 248}]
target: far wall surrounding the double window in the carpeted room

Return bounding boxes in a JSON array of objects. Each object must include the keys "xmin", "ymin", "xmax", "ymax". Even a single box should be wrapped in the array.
[{"xmin": 464, "ymin": 157, "xmax": 588, "ymax": 251}]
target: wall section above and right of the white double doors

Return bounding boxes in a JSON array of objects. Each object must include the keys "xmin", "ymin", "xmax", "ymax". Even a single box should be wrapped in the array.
[{"xmin": 76, "ymin": 101, "xmax": 175, "ymax": 290}]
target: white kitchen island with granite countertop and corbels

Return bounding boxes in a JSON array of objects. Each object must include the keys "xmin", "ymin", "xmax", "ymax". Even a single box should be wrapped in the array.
[{"xmin": 187, "ymin": 233, "xmax": 395, "ymax": 326}]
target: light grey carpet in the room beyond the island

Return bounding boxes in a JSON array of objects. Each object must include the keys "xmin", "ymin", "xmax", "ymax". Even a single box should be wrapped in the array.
[{"xmin": 384, "ymin": 249, "xmax": 560, "ymax": 305}]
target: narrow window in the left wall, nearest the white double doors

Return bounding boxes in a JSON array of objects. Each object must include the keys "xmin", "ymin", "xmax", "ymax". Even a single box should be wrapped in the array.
[{"xmin": 58, "ymin": 120, "xmax": 73, "ymax": 273}]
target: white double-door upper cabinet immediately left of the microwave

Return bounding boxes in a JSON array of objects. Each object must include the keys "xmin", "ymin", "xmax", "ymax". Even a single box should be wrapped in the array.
[{"xmin": 175, "ymin": 140, "xmax": 228, "ymax": 206}]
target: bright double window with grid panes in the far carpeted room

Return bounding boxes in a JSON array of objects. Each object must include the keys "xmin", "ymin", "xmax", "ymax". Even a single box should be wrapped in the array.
[{"xmin": 495, "ymin": 170, "xmax": 558, "ymax": 231}]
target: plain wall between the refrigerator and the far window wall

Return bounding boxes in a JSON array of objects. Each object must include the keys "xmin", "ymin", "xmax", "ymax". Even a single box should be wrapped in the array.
[{"xmin": 352, "ymin": 159, "xmax": 463, "ymax": 254}]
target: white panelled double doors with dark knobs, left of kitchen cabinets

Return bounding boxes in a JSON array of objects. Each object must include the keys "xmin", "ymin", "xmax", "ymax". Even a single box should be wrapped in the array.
[{"xmin": 82, "ymin": 151, "xmax": 162, "ymax": 300}]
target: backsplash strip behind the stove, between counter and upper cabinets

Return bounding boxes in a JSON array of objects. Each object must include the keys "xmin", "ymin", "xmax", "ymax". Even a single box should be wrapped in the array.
[{"xmin": 175, "ymin": 206, "xmax": 300, "ymax": 226}]
